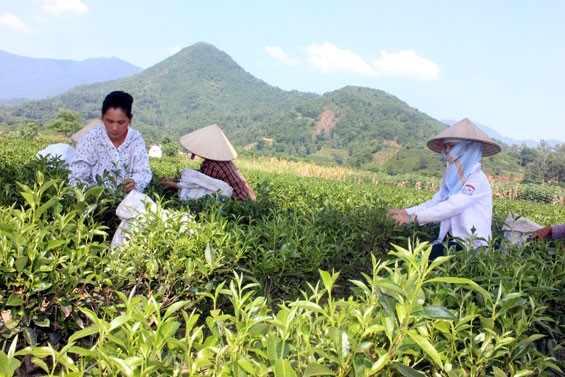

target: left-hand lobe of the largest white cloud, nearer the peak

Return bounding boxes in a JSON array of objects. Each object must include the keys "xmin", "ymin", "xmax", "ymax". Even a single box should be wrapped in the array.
[{"xmin": 306, "ymin": 42, "xmax": 375, "ymax": 76}]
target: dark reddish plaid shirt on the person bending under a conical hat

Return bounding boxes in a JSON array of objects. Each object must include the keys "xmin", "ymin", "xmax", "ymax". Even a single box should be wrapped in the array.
[{"xmin": 199, "ymin": 160, "xmax": 257, "ymax": 200}]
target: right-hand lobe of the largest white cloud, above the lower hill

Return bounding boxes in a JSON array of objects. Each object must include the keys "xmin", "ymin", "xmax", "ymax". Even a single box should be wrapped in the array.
[{"xmin": 372, "ymin": 50, "xmax": 440, "ymax": 80}]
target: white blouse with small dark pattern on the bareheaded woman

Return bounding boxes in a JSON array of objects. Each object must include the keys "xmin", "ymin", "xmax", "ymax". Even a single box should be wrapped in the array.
[{"xmin": 69, "ymin": 125, "xmax": 152, "ymax": 191}]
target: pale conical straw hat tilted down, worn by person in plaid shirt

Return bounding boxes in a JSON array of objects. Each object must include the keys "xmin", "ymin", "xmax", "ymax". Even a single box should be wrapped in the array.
[{"xmin": 180, "ymin": 124, "xmax": 237, "ymax": 161}]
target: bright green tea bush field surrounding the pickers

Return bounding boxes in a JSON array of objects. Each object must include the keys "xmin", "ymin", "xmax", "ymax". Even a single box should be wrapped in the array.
[{"xmin": 0, "ymin": 138, "xmax": 565, "ymax": 377}]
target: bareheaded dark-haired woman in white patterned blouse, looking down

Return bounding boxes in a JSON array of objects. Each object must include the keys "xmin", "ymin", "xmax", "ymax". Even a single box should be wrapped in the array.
[{"xmin": 69, "ymin": 91, "xmax": 152, "ymax": 191}]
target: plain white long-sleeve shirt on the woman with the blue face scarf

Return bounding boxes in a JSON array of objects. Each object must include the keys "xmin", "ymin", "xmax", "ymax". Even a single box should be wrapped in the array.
[{"xmin": 406, "ymin": 163, "xmax": 492, "ymax": 247}]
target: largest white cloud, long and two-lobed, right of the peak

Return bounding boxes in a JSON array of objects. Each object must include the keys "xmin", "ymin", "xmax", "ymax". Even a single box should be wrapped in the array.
[{"xmin": 306, "ymin": 42, "xmax": 440, "ymax": 80}]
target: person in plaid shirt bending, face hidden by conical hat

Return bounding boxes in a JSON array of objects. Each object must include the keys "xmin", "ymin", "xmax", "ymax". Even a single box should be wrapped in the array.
[{"xmin": 162, "ymin": 124, "xmax": 256, "ymax": 201}]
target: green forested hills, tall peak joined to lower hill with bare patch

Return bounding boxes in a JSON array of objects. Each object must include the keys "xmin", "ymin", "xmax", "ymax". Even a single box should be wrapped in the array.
[{"xmin": 0, "ymin": 43, "xmax": 468, "ymax": 170}]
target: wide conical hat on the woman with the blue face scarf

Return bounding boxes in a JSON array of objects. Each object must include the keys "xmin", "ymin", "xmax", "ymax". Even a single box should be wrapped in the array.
[{"xmin": 428, "ymin": 118, "xmax": 500, "ymax": 157}]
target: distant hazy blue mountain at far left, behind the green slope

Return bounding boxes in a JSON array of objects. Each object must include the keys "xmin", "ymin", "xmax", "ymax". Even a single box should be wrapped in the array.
[{"xmin": 0, "ymin": 51, "xmax": 142, "ymax": 100}]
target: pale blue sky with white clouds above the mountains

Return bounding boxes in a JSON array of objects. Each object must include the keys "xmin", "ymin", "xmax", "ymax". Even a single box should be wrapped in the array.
[{"xmin": 0, "ymin": 0, "xmax": 565, "ymax": 141}]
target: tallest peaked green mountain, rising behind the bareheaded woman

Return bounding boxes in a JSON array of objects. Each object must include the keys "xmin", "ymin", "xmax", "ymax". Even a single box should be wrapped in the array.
[{"xmin": 0, "ymin": 43, "xmax": 316, "ymax": 136}]
